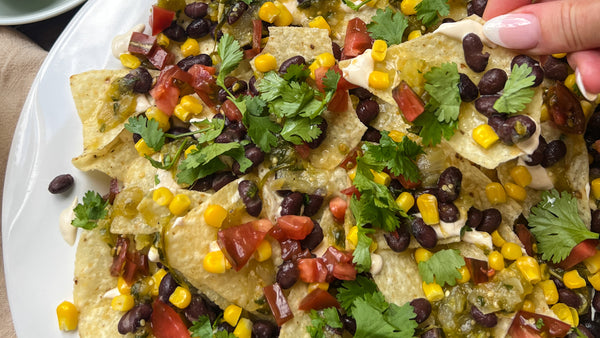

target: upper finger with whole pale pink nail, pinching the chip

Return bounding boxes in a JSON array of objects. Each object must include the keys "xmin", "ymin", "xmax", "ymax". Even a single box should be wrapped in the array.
[{"xmin": 484, "ymin": 0, "xmax": 600, "ymax": 55}]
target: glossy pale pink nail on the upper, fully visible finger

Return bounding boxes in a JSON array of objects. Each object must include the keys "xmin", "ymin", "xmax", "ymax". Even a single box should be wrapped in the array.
[{"xmin": 483, "ymin": 14, "xmax": 541, "ymax": 49}]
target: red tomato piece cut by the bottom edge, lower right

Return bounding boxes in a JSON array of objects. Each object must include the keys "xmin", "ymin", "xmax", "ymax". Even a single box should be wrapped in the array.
[{"xmin": 508, "ymin": 311, "xmax": 571, "ymax": 338}]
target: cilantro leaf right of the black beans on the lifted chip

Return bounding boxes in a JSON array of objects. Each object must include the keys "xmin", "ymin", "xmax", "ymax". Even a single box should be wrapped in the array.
[{"xmin": 494, "ymin": 63, "xmax": 535, "ymax": 113}]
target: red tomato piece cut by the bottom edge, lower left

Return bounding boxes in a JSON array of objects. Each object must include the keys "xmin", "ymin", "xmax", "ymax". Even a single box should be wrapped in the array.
[{"xmin": 150, "ymin": 299, "xmax": 190, "ymax": 338}]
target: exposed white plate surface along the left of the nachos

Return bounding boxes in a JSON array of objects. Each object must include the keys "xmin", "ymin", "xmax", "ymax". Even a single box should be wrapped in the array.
[{"xmin": 2, "ymin": 0, "xmax": 153, "ymax": 337}]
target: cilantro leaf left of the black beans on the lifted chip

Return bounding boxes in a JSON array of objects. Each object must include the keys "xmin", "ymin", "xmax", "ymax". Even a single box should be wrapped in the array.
[{"xmin": 424, "ymin": 63, "xmax": 461, "ymax": 123}]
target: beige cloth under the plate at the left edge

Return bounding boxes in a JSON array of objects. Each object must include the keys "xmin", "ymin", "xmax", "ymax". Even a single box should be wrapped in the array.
[{"xmin": 0, "ymin": 27, "xmax": 47, "ymax": 337}]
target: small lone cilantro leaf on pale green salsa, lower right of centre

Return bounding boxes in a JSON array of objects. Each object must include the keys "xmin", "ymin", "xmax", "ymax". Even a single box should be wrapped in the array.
[{"xmin": 419, "ymin": 249, "xmax": 465, "ymax": 286}]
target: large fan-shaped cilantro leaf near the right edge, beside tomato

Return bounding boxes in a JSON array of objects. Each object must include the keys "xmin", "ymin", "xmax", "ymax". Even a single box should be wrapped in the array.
[{"xmin": 527, "ymin": 189, "xmax": 598, "ymax": 263}]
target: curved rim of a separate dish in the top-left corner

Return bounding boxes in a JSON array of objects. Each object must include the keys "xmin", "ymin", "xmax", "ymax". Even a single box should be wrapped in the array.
[{"xmin": 0, "ymin": 0, "xmax": 85, "ymax": 25}]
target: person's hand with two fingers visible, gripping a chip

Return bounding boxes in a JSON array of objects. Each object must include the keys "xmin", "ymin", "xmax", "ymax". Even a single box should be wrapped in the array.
[{"xmin": 483, "ymin": 0, "xmax": 600, "ymax": 99}]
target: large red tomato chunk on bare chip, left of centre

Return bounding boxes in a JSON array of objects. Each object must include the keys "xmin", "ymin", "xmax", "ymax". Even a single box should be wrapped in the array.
[{"xmin": 217, "ymin": 221, "xmax": 270, "ymax": 271}]
